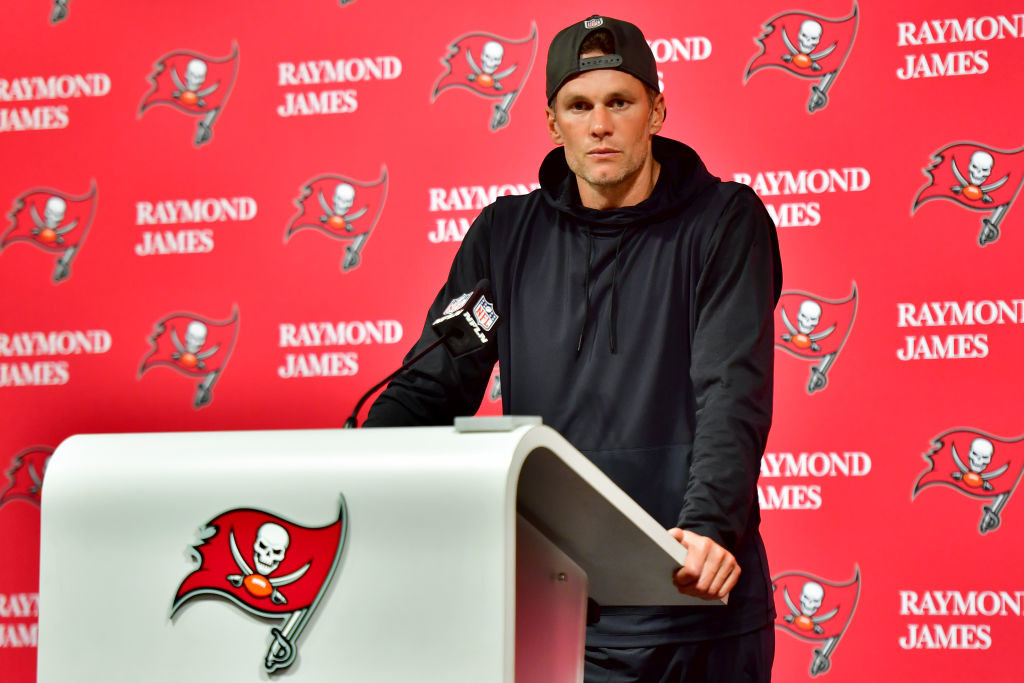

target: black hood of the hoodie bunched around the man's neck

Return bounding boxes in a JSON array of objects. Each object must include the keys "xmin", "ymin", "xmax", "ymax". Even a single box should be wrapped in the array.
[{"xmin": 540, "ymin": 135, "xmax": 719, "ymax": 227}]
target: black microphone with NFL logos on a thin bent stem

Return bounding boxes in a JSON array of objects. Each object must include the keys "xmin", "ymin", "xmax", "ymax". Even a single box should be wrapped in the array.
[{"xmin": 344, "ymin": 279, "xmax": 501, "ymax": 429}]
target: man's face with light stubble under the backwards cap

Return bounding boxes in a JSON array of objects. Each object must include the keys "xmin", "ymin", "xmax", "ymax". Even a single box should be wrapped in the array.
[{"xmin": 546, "ymin": 63, "xmax": 665, "ymax": 191}]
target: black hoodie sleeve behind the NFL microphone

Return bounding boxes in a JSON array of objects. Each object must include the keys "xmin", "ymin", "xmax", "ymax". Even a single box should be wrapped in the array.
[{"xmin": 364, "ymin": 207, "xmax": 498, "ymax": 427}]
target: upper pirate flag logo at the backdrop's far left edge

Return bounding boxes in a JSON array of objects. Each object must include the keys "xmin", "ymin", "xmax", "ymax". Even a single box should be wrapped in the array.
[{"xmin": 0, "ymin": 181, "xmax": 96, "ymax": 284}]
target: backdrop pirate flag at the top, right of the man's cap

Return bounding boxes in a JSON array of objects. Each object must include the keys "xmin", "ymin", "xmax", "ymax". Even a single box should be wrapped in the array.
[{"xmin": 743, "ymin": 3, "xmax": 857, "ymax": 114}]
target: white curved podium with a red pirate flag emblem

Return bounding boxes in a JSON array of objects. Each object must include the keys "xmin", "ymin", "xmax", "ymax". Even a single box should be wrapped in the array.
[{"xmin": 38, "ymin": 418, "xmax": 712, "ymax": 683}]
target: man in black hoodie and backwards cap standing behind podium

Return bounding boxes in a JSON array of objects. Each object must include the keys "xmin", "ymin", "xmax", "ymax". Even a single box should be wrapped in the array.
[{"xmin": 367, "ymin": 15, "xmax": 781, "ymax": 682}]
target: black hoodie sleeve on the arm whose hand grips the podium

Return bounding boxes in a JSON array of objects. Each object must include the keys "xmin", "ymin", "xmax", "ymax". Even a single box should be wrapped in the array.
[{"xmin": 679, "ymin": 187, "xmax": 782, "ymax": 552}]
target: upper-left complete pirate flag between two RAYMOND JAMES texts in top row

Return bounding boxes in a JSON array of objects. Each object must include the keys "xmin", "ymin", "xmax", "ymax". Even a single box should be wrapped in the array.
[{"xmin": 138, "ymin": 45, "xmax": 239, "ymax": 146}]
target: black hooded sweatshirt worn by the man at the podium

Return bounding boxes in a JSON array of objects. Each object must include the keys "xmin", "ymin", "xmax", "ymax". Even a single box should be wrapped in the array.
[{"xmin": 366, "ymin": 136, "xmax": 782, "ymax": 646}]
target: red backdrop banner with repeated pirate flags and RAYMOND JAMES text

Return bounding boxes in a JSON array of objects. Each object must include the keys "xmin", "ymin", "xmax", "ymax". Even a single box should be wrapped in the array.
[{"xmin": 0, "ymin": 0, "xmax": 1024, "ymax": 683}]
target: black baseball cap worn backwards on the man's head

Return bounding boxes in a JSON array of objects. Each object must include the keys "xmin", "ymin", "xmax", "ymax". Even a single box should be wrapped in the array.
[{"xmin": 547, "ymin": 14, "xmax": 662, "ymax": 104}]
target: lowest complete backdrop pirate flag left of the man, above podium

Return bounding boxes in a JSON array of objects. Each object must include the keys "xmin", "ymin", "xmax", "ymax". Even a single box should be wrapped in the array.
[{"xmin": 138, "ymin": 308, "xmax": 239, "ymax": 409}]
